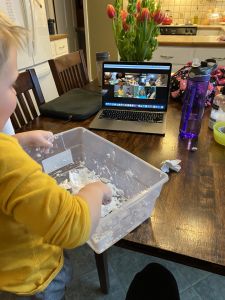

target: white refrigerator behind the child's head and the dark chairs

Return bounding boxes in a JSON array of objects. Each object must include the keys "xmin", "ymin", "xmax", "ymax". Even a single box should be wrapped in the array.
[{"xmin": 0, "ymin": 0, "xmax": 58, "ymax": 101}]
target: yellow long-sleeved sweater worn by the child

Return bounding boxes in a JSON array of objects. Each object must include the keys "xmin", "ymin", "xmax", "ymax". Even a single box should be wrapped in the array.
[{"xmin": 0, "ymin": 133, "xmax": 91, "ymax": 295}]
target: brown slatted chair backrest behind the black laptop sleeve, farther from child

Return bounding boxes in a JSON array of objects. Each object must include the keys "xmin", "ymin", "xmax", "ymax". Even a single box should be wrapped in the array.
[{"xmin": 48, "ymin": 50, "xmax": 89, "ymax": 95}]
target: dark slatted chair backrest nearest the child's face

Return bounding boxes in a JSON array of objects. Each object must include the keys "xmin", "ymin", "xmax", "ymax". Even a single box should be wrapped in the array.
[{"xmin": 11, "ymin": 69, "xmax": 45, "ymax": 130}]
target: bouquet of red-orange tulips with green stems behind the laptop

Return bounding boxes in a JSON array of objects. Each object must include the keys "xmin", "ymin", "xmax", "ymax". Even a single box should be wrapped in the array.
[{"xmin": 107, "ymin": 0, "xmax": 165, "ymax": 61}]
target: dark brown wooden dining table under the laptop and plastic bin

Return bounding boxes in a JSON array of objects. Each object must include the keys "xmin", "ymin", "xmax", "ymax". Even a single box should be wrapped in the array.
[{"xmin": 20, "ymin": 89, "xmax": 225, "ymax": 293}]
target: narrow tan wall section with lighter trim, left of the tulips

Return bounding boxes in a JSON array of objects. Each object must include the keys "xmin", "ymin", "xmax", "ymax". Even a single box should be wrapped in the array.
[{"xmin": 84, "ymin": 0, "xmax": 118, "ymax": 79}]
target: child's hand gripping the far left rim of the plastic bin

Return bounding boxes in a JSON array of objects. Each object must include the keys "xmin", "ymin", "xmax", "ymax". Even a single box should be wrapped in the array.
[{"xmin": 15, "ymin": 130, "xmax": 54, "ymax": 148}]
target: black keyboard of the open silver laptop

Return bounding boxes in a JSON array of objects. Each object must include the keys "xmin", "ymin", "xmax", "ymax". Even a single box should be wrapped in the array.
[{"xmin": 99, "ymin": 109, "xmax": 163, "ymax": 123}]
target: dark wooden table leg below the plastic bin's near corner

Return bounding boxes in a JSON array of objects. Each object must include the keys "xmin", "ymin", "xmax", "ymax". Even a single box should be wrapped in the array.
[{"xmin": 95, "ymin": 251, "xmax": 110, "ymax": 294}]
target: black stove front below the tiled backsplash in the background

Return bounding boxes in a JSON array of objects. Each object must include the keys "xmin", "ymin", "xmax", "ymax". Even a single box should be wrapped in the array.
[{"xmin": 160, "ymin": 25, "xmax": 197, "ymax": 35}]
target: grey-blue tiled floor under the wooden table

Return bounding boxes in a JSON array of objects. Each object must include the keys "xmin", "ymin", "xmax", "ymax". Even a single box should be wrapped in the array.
[{"xmin": 66, "ymin": 245, "xmax": 225, "ymax": 300}]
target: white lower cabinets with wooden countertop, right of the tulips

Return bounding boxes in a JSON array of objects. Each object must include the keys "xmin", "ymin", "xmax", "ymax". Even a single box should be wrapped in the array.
[{"xmin": 152, "ymin": 26, "xmax": 225, "ymax": 72}]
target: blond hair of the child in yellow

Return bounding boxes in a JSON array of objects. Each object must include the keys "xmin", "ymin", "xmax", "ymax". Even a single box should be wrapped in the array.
[{"xmin": 0, "ymin": 11, "xmax": 26, "ymax": 72}]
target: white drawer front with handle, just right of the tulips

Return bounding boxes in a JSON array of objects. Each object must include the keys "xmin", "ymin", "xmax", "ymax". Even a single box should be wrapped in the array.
[{"xmin": 152, "ymin": 46, "xmax": 194, "ymax": 72}]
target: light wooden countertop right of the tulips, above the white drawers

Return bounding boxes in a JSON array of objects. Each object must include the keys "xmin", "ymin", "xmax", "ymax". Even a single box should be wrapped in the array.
[{"xmin": 157, "ymin": 35, "xmax": 225, "ymax": 48}]
